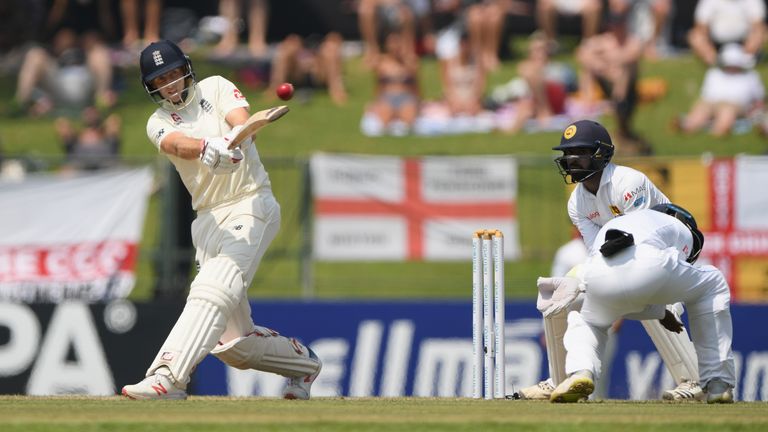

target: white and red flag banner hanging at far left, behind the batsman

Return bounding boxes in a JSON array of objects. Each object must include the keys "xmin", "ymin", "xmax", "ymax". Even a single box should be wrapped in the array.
[{"xmin": 0, "ymin": 168, "xmax": 152, "ymax": 303}]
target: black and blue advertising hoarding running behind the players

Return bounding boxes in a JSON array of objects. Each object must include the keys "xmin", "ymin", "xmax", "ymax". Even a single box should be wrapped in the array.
[{"xmin": 0, "ymin": 299, "xmax": 768, "ymax": 401}]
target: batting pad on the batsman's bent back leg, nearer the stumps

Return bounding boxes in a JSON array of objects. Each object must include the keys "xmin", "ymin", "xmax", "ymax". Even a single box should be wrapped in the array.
[{"xmin": 211, "ymin": 327, "xmax": 320, "ymax": 378}]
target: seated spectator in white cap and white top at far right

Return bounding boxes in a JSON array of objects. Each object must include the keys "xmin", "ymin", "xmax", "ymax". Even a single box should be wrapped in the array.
[{"xmin": 677, "ymin": 43, "xmax": 765, "ymax": 137}]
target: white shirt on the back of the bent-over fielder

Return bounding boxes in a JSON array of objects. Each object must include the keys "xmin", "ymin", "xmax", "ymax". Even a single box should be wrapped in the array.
[{"xmin": 592, "ymin": 209, "xmax": 693, "ymax": 260}]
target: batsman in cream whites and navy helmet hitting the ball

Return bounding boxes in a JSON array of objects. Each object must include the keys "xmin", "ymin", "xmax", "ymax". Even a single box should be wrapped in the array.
[{"xmin": 122, "ymin": 40, "xmax": 322, "ymax": 399}]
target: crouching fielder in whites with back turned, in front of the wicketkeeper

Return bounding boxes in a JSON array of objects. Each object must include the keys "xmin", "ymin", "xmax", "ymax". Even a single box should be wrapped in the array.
[{"xmin": 544, "ymin": 204, "xmax": 736, "ymax": 403}]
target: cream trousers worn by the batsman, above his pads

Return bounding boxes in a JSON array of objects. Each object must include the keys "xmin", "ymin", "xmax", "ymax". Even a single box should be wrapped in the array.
[{"xmin": 192, "ymin": 189, "xmax": 281, "ymax": 343}]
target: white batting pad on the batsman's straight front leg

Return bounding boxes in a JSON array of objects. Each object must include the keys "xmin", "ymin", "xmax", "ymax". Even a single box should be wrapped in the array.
[{"xmin": 147, "ymin": 258, "xmax": 244, "ymax": 386}]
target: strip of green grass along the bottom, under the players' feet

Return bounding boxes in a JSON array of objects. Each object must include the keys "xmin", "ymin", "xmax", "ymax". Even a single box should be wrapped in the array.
[{"xmin": 0, "ymin": 396, "xmax": 768, "ymax": 432}]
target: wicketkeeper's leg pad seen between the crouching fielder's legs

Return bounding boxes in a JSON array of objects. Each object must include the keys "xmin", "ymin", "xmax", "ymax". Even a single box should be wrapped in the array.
[{"xmin": 640, "ymin": 320, "xmax": 699, "ymax": 384}]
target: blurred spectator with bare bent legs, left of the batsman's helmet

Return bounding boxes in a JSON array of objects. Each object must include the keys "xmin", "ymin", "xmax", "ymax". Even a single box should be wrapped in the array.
[{"xmin": 15, "ymin": 29, "xmax": 116, "ymax": 115}]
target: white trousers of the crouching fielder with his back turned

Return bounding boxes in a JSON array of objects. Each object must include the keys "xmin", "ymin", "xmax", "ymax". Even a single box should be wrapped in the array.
[{"xmin": 564, "ymin": 245, "xmax": 736, "ymax": 386}]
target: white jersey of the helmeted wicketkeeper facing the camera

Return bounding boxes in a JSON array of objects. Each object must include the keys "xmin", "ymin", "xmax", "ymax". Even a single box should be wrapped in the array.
[{"xmin": 568, "ymin": 163, "xmax": 669, "ymax": 253}]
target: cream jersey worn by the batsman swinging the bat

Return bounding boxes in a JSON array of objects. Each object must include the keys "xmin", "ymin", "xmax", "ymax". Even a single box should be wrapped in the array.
[{"xmin": 147, "ymin": 76, "xmax": 270, "ymax": 211}]
